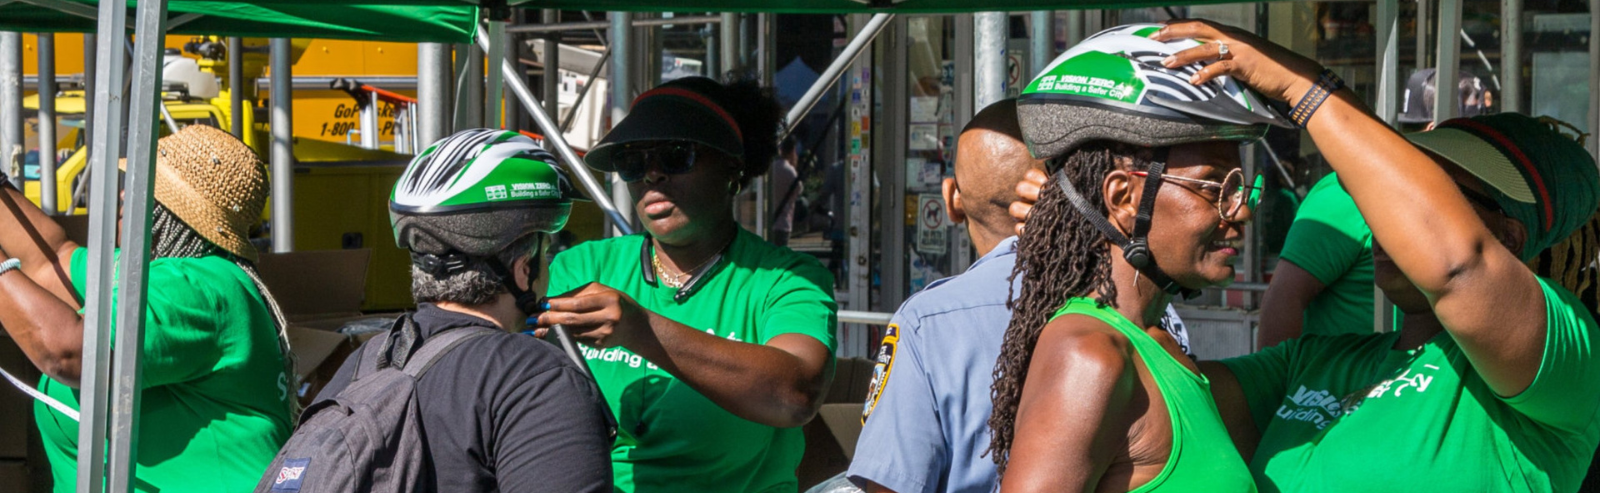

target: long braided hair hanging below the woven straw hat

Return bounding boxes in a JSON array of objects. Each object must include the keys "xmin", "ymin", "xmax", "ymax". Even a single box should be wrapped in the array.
[{"xmin": 150, "ymin": 202, "xmax": 301, "ymax": 423}]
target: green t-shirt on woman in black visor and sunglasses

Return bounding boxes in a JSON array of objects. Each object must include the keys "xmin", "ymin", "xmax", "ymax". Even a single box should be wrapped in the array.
[{"xmin": 550, "ymin": 229, "xmax": 837, "ymax": 493}]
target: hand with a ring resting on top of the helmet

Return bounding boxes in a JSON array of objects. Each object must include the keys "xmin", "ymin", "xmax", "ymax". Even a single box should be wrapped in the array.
[{"xmin": 1150, "ymin": 19, "xmax": 1322, "ymax": 104}]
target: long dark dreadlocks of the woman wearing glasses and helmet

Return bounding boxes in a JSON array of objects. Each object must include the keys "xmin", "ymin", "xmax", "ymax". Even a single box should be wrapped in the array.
[{"xmin": 987, "ymin": 141, "xmax": 1152, "ymax": 474}]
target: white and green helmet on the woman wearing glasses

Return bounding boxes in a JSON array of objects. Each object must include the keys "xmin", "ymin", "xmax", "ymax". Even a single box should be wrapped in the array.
[{"xmin": 1018, "ymin": 24, "xmax": 1291, "ymax": 158}]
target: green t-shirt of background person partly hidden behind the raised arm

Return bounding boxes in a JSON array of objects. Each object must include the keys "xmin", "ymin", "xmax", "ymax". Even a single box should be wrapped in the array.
[{"xmin": 1278, "ymin": 173, "xmax": 1373, "ymax": 336}]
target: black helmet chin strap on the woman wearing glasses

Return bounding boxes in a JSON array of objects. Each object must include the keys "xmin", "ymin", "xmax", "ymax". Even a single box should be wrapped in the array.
[{"xmin": 1054, "ymin": 149, "xmax": 1200, "ymax": 299}]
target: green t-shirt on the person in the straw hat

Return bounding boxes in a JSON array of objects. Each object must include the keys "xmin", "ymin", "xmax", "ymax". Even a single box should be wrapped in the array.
[{"xmin": 34, "ymin": 248, "xmax": 293, "ymax": 493}]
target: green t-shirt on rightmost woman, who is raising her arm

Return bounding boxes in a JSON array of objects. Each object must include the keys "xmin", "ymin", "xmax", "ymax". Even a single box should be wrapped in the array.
[{"xmin": 1222, "ymin": 279, "xmax": 1600, "ymax": 491}]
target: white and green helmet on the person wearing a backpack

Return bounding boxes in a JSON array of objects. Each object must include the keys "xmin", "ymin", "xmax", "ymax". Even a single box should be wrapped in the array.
[{"xmin": 389, "ymin": 128, "xmax": 576, "ymax": 259}]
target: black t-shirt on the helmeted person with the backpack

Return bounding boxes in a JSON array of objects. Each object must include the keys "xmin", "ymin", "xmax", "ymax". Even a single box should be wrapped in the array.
[{"xmin": 317, "ymin": 304, "xmax": 611, "ymax": 493}]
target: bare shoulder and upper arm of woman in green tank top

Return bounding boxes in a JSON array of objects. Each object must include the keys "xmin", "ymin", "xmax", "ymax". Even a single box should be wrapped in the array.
[{"xmin": 1000, "ymin": 315, "xmax": 1134, "ymax": 493}]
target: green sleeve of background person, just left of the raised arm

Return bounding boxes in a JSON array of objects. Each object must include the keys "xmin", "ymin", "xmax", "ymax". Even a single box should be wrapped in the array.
[{"xmin": 1280, "ymin": 174, "xmax": 1371, "ymax": 285}]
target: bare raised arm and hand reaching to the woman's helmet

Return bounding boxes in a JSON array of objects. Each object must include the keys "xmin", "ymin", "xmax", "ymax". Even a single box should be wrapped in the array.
[{"xmin": 1157, "ymin": 21, "xmax": 1546, "ymax": 395}]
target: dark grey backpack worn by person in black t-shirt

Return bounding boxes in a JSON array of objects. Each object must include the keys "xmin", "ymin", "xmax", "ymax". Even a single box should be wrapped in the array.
[{"xmin": 256, "ymin": 315, "xmax": 496, "ymax": 493}]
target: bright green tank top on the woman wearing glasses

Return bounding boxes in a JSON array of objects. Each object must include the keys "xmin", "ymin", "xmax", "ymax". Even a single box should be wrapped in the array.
[{"xmin": 1050, "ymin": 298, "xmax": 1256, "ymax": 493}]
